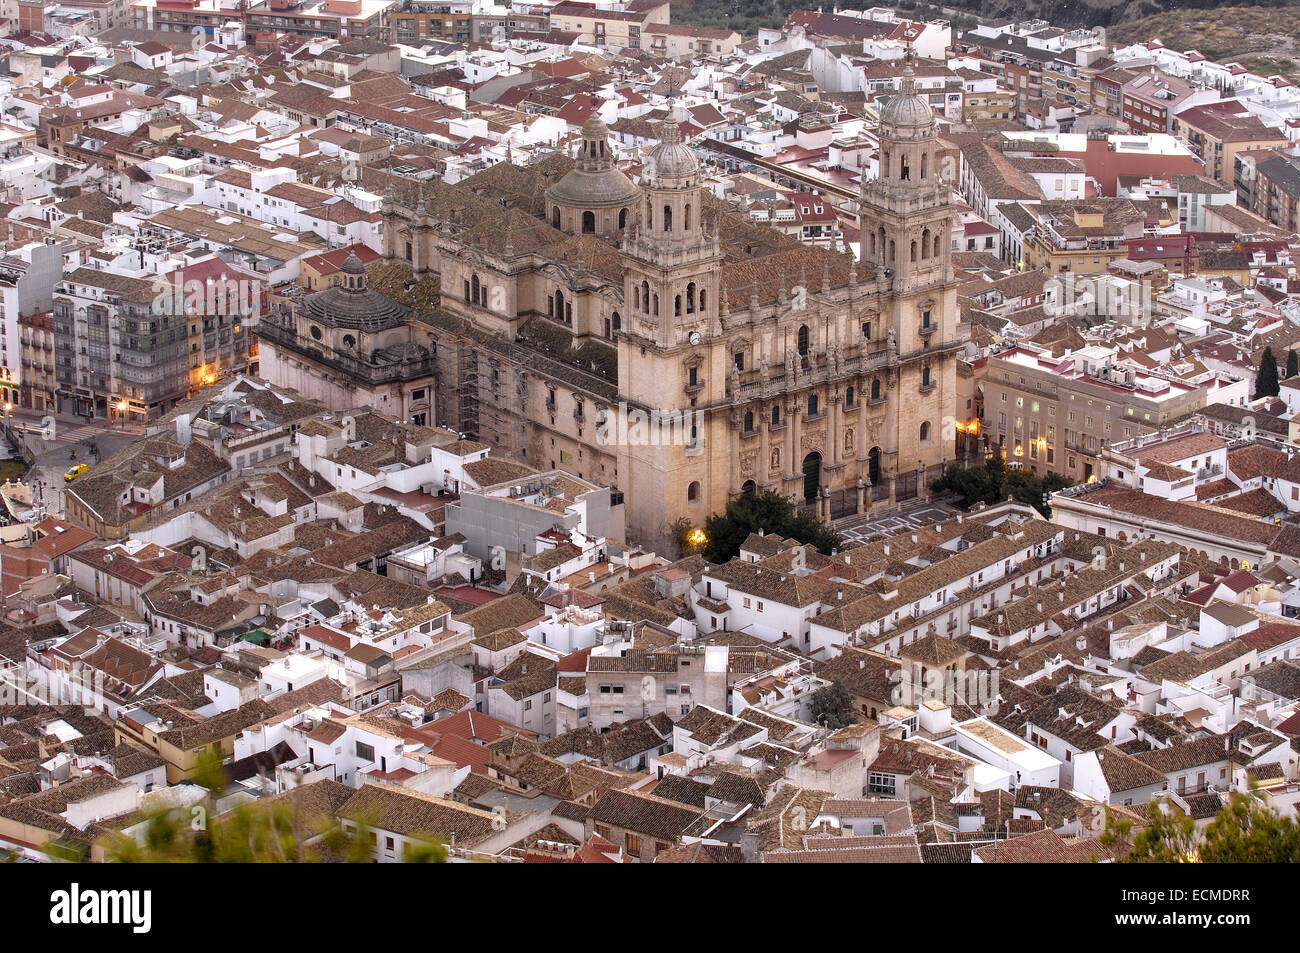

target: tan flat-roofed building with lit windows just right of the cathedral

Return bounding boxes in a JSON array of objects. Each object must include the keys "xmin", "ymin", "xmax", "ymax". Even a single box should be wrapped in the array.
[{"xmin": 982, "ymin": 345, "xmax": 1205, "ymax": 482}]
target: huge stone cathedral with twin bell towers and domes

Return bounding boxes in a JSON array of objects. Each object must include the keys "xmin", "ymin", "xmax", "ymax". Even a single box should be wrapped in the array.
[{"xmin": 263, "ymin": 69, "xmax": 961, "ymax": 547}]
